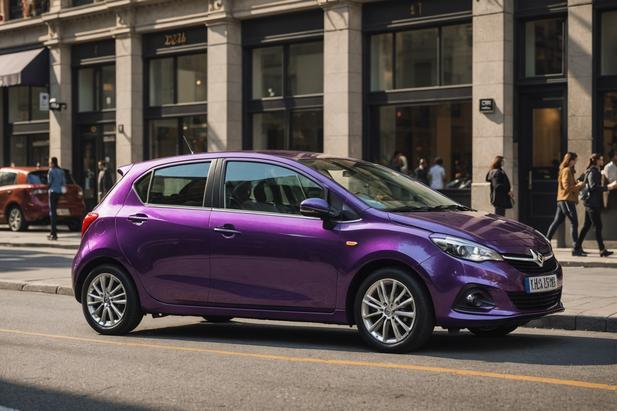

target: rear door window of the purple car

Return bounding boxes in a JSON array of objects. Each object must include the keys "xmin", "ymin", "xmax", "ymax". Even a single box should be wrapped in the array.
[{"xmin": 146, "ymin": 162, "xmax": 210, "ymax": 207}]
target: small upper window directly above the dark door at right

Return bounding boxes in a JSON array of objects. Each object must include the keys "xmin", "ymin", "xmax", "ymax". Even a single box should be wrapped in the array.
[{"xmin": 525, "ymin": 18, "xmax": 564, "ymax": 77}]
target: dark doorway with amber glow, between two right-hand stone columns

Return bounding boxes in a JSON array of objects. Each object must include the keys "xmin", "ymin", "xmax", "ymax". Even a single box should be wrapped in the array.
[{"xmin": 518, "ymin": 92, "xmax": 567, "ymax": 233}]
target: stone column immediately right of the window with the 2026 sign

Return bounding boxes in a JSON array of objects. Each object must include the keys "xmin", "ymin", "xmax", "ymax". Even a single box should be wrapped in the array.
[{"xmin": 207, "ymin": 18, "xmax": 242, "ymax": 151}]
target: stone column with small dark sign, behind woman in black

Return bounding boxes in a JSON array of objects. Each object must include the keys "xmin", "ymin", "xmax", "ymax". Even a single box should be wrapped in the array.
[{"xmin": 471, "ymin": 0, "xmax": 518, "ymax": 218}]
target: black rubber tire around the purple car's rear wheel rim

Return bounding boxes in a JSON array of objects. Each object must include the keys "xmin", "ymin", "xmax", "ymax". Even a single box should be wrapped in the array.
[{"xmin": 81, "ymin": 264, "xmax": 143, "ymax": 335}]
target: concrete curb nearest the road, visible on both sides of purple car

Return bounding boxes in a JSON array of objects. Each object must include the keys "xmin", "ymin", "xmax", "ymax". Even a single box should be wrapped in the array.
[{"xmin": 0, "ymin": 280, "xmax": 617, "ymax": 333}]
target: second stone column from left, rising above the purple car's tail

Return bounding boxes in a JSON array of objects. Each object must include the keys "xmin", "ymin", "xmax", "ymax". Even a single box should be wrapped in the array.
[{"xmin": 116, "ymin": 31, "xmax": 144, "ymax": 166}]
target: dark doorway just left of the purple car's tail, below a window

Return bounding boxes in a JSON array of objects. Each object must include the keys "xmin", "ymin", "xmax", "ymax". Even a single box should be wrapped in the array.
[{"xmin": 77, "ymin": 123, "xmax": 116, "ymax": 211}]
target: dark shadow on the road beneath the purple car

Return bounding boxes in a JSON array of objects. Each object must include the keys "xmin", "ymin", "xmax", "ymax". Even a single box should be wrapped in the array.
[{"xmin": 131, "ymin": 321, "xmax": 617, "ymax": 366}]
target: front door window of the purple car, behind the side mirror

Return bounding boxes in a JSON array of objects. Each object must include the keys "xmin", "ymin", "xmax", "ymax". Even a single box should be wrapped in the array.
[{"xmin": 225, "ymin": 161, "xmax": 324, "ymax": 215}]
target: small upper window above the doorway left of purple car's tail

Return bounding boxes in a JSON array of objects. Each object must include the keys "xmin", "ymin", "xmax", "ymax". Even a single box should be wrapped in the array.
[{"xmin": 77, "ymin": 64, "xmax": 116, "ymax": 113}]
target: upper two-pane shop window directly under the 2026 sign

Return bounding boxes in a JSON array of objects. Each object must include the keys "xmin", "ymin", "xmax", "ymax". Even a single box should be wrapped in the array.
[{"xmin": 148, "ymin": 53, "xmax": 208, "ymax": 107}]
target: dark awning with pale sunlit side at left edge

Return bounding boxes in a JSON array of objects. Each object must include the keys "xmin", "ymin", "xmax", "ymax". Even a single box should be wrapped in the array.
[{"xmin": 0, "ymin": 48, "xmax": 49, "ymax": 87}]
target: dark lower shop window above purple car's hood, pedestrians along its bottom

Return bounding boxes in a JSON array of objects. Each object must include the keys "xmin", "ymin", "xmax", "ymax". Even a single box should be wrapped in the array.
[{"xmin": 372, "ymin": 102, "xmax": 472, "ymax": 189}]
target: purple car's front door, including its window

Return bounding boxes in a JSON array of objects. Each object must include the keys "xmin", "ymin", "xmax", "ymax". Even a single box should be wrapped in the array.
[{"xmin": 209, "ymin": 160, "xmax": 344, "ymax": 311}]
